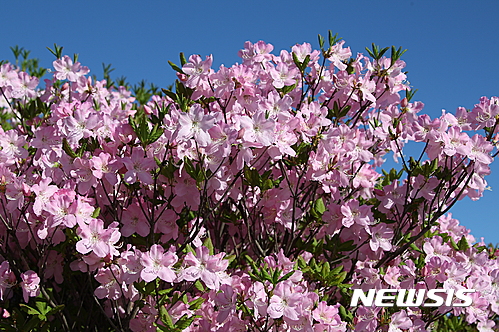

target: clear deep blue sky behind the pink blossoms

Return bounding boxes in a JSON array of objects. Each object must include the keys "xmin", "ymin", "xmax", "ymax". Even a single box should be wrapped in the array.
[{"xmin": 0, "ymin": 0, "xmax": 499, "ymax": 243}]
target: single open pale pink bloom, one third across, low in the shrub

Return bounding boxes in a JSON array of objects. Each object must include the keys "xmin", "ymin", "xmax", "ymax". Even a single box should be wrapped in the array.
[{"xmin": 140, "ymin": 244, "xmax": 178, "ymax": 282}]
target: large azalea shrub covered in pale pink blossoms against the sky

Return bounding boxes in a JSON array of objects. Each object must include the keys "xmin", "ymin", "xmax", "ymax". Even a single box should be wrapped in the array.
[{"xmin": 0, "ymin": 34, "xmax": 499, "ymax": 332}]
